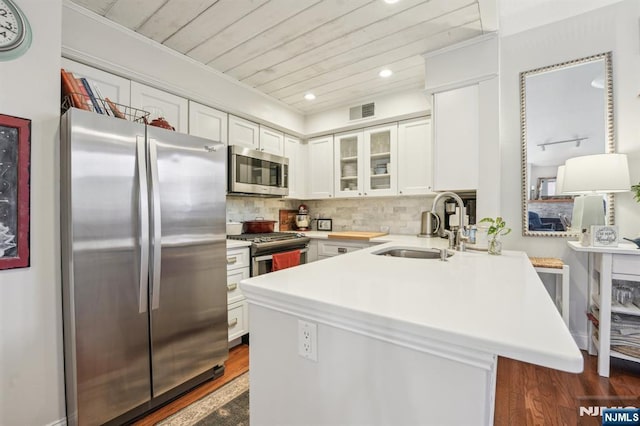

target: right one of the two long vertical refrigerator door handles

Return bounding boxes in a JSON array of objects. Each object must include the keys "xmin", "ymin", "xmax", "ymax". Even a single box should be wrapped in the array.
[{"xmin": 149, "ymin": 138, "xmax": 162, "ymax": 309}]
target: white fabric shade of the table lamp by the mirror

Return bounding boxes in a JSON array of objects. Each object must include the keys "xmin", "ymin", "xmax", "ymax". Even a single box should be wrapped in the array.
[{"xmin": 562, "ymin": 154, "xmax": 631, "ymax": 194}]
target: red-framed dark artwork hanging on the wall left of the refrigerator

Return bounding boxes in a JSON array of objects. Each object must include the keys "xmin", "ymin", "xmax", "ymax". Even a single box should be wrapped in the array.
[{"xmin": 0, "ymin": 114, "xmax": 31, "ymax": 269}]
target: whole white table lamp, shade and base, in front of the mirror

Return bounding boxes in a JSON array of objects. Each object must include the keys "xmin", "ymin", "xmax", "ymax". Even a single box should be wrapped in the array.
[{"xmin": 562, "ymin": 154, "xmax": 631, "ymax": 232}]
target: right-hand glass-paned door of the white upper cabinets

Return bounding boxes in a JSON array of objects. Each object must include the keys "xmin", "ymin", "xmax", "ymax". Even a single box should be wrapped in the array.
[{"xmin": 363, "ymin": 124, "xmax": 398, "ymax": 197}]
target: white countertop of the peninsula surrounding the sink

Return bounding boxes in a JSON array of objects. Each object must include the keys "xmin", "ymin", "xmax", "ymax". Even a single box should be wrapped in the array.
[{"xmin": 241, "ymin": 233, "xmax": 583, "ymax": 372}]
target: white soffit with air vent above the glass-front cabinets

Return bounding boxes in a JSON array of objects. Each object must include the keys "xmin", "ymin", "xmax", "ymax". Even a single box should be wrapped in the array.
[{"xmin": 305, "ymin": 89, "xmax": 431, "ymax": 137}]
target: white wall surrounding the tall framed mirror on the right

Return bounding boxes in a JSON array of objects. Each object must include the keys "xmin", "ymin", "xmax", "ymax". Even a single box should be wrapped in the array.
[{"xmin": 496, "ymin": 0, "xmax": 640, "ymax": 346}]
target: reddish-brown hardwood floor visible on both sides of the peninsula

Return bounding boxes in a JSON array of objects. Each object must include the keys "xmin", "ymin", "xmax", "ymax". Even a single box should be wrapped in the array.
[{"xmin": 135, "ymin": 345, "xmax": 640, "ymax": 426}]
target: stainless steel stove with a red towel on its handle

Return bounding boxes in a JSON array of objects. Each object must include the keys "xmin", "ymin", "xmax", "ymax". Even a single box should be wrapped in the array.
[{"xmin": 227, "ymin": 232, "xmax": 310, "ymax": 277}]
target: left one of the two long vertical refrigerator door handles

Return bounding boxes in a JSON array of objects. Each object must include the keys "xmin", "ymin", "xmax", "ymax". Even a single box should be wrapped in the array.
[{"xmin": 136, "ymin": 136, "xmax": 149, "ymax": 313}]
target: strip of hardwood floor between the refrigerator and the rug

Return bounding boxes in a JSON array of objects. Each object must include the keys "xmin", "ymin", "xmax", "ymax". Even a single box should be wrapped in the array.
[{"xmin": 134, "ymin": 344, "xmax": 249, "ymax": 426}]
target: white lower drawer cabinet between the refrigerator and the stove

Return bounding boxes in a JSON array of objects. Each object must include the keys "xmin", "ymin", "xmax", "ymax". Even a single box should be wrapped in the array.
[{"xmin": 227, "ymin": 247, "xmax": 250, "ymax": 341}]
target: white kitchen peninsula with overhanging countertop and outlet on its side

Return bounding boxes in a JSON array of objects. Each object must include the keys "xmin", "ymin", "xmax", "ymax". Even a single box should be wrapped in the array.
[{"xmin": 241, "ymin": 236, "xmax": 583, "ymax": 425}]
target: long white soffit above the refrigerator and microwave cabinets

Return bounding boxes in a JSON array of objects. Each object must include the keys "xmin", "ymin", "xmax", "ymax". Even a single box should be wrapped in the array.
[{"xmin": 62, "ymin": 0, "xmax": 304, "ymax": 135}]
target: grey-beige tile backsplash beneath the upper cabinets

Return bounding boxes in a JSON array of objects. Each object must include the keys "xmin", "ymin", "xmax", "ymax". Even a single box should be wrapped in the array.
[{"xmin": 227, "ymin": 196, "xmax": 434, "ymax": 235}]
